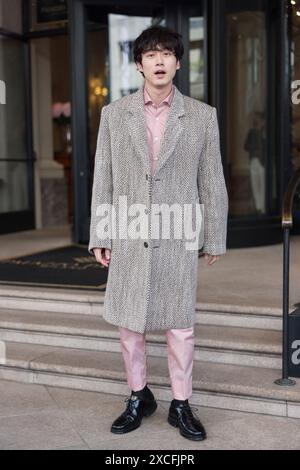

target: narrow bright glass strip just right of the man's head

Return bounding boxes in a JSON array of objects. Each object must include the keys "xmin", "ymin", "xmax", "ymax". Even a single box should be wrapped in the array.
[{"xmin": 189, "ymin": 7, "xmax": 205, "ymax": 101}]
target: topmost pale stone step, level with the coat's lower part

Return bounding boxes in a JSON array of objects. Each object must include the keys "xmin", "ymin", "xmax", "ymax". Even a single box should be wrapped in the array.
[{"xmin": 0, "ymin": 286, "xmax": 284, "ymax": 331}]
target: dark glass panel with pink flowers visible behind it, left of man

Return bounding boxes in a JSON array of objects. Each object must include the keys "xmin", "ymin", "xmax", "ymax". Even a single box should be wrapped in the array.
[{"xmin": 31, "ymin": 34, "xmax": 74, "ymax": 223}]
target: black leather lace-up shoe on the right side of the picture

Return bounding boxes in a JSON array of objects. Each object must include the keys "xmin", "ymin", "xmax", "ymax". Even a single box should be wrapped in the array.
[{"xmin": 168, "ymin": 400, "xmax": 206, "ymax": 441}]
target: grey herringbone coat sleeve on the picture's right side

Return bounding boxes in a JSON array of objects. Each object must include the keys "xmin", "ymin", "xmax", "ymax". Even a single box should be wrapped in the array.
[{"xmin": 197, "ymin": 108, "xmax": 228, "ymax": 255}]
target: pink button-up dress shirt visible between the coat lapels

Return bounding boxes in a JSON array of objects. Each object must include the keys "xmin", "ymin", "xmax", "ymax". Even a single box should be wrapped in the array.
[{"xmin": 144, "ymin": 85, "xmax": 175, "ymax": 175}]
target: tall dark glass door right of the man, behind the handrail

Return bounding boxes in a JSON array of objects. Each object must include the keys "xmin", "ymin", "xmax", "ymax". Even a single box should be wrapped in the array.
[{"xmin": 223, "ymin": 0, "xmax": 284, "ymax": 246}]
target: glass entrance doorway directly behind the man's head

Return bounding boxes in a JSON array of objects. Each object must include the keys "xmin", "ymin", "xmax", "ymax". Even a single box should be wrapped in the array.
[{"xmin": 86, "ymin": 2, "xmax": 207, "ymax": 162}]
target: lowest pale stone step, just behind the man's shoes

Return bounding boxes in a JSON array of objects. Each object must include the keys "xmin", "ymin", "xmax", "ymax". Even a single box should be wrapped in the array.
[{"xmin": 0, "ymin": 342, "xmax": 300, "ymax": 419}]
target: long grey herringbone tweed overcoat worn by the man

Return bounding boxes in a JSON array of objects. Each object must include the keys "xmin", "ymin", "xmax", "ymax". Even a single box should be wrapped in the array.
[{"xmin": 88, "ymin": 86, "xmax": 228, "ymax": 333}]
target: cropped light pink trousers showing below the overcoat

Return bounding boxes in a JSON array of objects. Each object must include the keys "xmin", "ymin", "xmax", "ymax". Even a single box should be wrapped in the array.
[{"xmin": 119, "ymin": 327, "xmax": 195, "ymax": 400}]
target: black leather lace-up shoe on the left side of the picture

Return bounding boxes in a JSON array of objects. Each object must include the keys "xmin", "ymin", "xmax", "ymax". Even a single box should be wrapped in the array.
[{"xmin": 111, "ymin": 385, "xmax": 157, "ymax": 434}]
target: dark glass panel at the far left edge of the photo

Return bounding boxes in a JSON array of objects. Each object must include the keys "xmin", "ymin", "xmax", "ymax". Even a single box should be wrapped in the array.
[{"xmin": 0, "ymin": 36, "xmax": 29, "ymax": 213}]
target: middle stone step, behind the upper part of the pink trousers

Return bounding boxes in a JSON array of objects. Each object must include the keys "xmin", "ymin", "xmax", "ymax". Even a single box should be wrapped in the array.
[{"xmin": 0, "ymin": 309, "xmax": 282, "ymax": 369}]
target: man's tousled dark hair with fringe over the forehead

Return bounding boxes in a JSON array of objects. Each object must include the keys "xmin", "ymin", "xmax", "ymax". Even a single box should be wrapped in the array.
[{"xmin": 133, "ymin": 25, "xmax": 184, "ymax": 64}]
